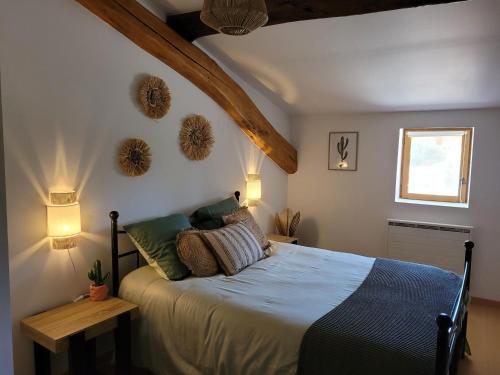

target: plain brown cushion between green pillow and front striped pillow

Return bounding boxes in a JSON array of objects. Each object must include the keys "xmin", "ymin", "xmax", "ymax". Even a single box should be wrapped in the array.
[{"xmin": 177, "ymin": 229, "xmax": 220, "ymax": 277}]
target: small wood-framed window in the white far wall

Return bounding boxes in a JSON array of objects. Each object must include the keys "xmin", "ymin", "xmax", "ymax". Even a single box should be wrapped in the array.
[{"xmin": 396, "ymin": 128, "xmax": 473, "ymax": 206}]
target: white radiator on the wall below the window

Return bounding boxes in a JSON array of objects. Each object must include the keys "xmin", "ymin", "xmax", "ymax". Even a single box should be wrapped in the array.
[{"xmin": 387, "ymin": 219, "xmax": 473, "ymax": 274}]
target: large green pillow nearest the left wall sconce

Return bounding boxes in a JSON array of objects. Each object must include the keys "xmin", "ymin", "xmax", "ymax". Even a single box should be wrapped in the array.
[{"xmin": 124, "ymin": 214, "xmax": 191, "ymax": 280}]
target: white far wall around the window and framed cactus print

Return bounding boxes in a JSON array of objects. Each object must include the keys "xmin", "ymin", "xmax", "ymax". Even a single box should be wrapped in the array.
[{"xmin": 288, "ymin": 110, "xmax": 500, "ymax": 300}]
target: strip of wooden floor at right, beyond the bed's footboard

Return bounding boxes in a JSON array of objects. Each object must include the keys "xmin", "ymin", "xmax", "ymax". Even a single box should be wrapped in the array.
[{"xmin": 458, "ymin": 303, "xmax": 500, "ymax": 375}]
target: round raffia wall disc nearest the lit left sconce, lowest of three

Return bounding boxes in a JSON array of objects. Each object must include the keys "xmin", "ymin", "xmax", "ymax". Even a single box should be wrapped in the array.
[{"xmin": 118, "ymin": 138, "xmax": 151, "ymax": 177}]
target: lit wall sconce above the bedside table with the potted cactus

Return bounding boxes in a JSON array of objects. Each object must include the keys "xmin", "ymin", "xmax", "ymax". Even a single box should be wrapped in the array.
[{"xmin": 47, "ymin": 191, "xmax": 82, "ymax": 250}]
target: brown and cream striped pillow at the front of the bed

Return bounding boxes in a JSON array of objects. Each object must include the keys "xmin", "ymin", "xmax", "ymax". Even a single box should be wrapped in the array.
[{"xmin": 203, "ymin": 223, "xmax": 264, "ymax": 276}]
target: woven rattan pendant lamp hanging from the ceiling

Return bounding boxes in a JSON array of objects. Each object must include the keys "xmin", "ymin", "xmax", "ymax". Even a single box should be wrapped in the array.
[{"xmin": 200, "ymin": 0, "xmax": 268, "ymax": 35}]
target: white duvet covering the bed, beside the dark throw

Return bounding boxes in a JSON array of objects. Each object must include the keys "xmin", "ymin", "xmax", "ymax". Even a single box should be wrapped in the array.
[{"xmin": 120, "ymin": 243, "xmax": 375, "ymax": 375}]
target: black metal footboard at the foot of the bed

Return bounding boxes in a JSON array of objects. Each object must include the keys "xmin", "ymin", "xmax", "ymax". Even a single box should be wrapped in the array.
[{"xmin": 435, "ymin": 241, "xmax": 474, "ymax": 375}]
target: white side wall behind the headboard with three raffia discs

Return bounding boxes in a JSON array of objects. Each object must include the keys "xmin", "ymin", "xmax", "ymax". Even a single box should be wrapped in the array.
[{"xmin": 0, "ymin": 0, "xmax": 289, "ymax": 375}]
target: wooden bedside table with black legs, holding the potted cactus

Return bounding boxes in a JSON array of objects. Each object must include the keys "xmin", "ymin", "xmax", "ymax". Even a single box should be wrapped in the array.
[{"xmin": 21, "ymin": 298, "xmax": 138, "ymax": 375}]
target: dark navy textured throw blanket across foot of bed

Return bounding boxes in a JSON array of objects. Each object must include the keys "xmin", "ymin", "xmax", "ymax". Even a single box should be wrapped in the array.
[{"xmin": 298, "ymin": 259, "xmax": 462, "ymax": 375}]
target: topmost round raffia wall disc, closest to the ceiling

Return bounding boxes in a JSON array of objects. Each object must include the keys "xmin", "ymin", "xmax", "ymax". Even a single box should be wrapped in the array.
[{"xmin": 139, "ymin": 76, "xmax": 171, "ymax": 119}]
